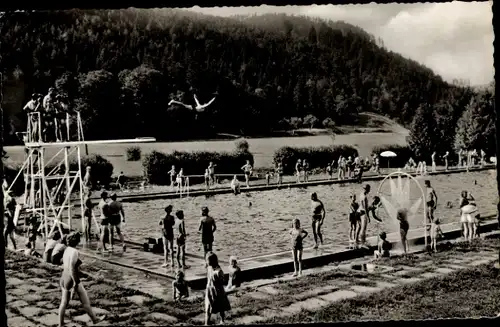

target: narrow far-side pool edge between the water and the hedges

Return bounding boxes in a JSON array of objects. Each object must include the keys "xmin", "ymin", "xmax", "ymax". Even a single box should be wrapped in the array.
[{"xmin": 75, "ymin": 164, "xmax": 496, "ymax": 205}]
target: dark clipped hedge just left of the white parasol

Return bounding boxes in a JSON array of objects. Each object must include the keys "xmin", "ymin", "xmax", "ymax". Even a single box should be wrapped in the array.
[{"xmin": 273, "ymin": 145, "xmax": 358, "ymax": 175}]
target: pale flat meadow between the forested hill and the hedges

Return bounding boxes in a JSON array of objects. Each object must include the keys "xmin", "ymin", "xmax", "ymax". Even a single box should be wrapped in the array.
[{"xmin": 5, "ymin": 114, "xmax": 406, "ymax": 177}]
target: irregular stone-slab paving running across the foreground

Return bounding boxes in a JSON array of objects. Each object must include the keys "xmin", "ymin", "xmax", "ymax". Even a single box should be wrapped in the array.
[{"xmin": 5, "ymin": 238, "xmax": 498, "ymax": 327}]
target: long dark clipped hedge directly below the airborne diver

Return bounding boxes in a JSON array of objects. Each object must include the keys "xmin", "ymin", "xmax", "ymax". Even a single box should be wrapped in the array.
[{"xmin": 142, "ymin": 151, "xmax": 254, "ymax": 185}]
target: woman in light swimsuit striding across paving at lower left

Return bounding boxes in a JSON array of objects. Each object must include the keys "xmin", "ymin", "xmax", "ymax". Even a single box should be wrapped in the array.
[{"xmin": 59, "ymin": 233, "xmax": 104, "ymax": 327}]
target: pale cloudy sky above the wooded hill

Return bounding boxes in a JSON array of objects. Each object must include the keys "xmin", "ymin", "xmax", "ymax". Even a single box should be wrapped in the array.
[{"xmin": 191, "ymin": 1, "xmax": 494, "ymax": 85}]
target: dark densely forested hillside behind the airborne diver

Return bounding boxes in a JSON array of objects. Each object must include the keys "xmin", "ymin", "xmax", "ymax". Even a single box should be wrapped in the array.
[{"xmin": 0, "ymin": 9, "xmax": 472, "ymax": 144}]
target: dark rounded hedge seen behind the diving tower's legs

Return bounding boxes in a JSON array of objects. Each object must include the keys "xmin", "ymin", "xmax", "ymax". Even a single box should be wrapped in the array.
[{"xmin": 4, "ymin": 154, "xmax": 113, "ymax": 196}]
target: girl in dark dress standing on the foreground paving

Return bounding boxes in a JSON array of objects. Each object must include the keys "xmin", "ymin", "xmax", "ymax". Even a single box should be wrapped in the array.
[{"xmin": 205, "ymin": 252, "xmax": 231, "ymax": 326}]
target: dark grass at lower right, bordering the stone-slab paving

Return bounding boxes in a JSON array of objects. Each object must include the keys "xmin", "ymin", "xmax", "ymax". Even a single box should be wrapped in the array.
[{"xmin": 265, "ymin": 239, "xmax": 500, "ymax": 324}]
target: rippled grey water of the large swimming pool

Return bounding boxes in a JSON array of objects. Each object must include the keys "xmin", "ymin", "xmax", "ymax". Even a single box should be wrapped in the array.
[{"xmin": 120, "ymin": 170, "xmax": 497, "ymax": 258}]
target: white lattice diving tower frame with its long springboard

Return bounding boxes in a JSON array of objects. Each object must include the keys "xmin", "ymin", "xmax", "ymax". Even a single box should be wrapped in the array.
[{"xmin": 9, "ymin": 113, "xmax": 156, "ymax": 245}]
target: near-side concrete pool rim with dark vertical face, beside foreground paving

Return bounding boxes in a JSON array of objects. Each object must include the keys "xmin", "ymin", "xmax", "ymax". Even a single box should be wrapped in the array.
[{"xmin": 76, "ymin": 213, "xmax": 498, "ymax": 289}]
